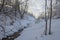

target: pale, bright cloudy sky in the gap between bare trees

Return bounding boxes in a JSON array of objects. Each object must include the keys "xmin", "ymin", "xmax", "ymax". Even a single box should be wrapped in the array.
[{"xmin": 29, "ymin": 0, "xmax": 44, "ymax": 13}]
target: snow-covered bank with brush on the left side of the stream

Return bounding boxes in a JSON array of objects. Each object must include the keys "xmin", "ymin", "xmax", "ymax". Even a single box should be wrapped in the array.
[{"xmin": 0, "ymin": 14, "xmax": 35, "ymax": 39}]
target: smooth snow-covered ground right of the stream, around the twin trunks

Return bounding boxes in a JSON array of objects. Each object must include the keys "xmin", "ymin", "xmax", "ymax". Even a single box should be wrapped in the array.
[{"xmin": 15, "ymin": 19, "xmax": 60, "ymax": 40}]
